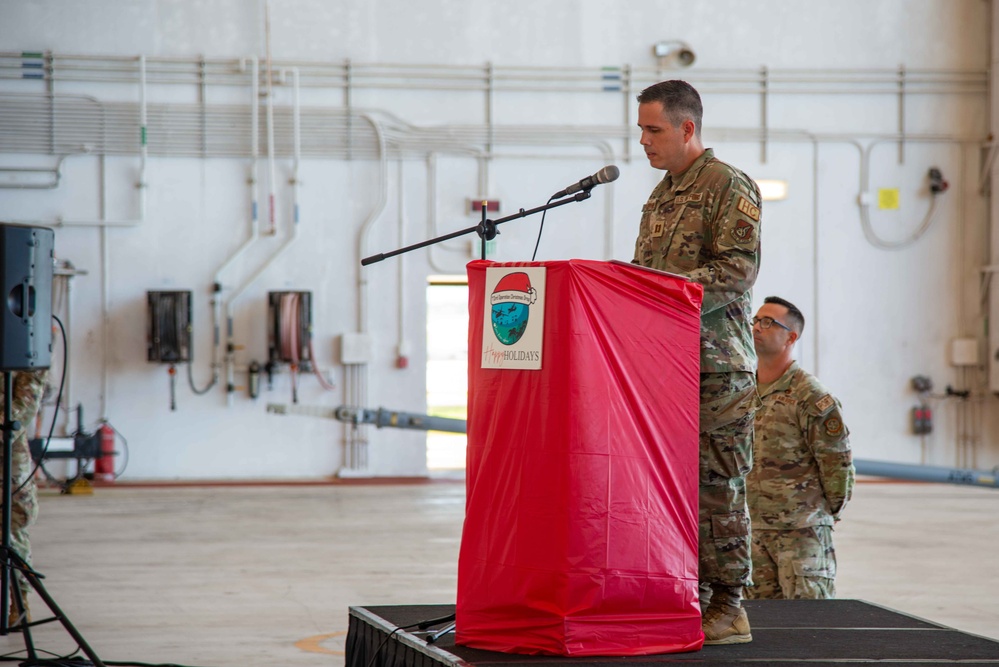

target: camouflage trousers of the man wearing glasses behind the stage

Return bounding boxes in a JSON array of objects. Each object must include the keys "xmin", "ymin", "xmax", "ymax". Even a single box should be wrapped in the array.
[{"xmin": 746, "ymin": 526, "xmax": 836, "ymax": 600}]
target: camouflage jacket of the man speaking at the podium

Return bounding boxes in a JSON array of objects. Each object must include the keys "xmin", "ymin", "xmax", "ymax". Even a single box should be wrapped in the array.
[{"xmin": 632, "ymin": 148, "xmax": 762, "ymax": 373}]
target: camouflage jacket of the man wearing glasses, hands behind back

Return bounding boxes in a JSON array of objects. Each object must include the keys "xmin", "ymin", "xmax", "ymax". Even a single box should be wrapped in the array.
[{"xmin": 746, "ymin": 362, "xmax": 854, "ymax": 530}]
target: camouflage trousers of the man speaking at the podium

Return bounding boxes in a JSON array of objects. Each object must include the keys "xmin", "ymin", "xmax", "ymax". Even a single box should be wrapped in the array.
[{"xmin": 698, "ymin": 373, "xmax": 759, "ymax": 586}]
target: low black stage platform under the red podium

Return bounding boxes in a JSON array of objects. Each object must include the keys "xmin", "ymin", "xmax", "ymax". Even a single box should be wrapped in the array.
[{"xmin": 346, "ymin": 600, "xmax": 999, "ymax": 667}]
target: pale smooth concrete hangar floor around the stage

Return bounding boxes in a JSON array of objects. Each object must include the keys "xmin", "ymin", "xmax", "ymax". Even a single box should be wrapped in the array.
[{"xmin": 0, "ymin": 481, "xmax": 999, "ymax": 667}]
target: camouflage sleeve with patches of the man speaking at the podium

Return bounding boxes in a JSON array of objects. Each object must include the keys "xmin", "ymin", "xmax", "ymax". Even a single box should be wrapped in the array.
[{"xmin": 688, "ymin": 172, "xmax": 761, "ymax": 315}]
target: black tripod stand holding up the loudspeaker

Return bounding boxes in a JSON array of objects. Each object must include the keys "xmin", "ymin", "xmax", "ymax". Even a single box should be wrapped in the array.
[{"xmin": 0, "ymin": 369, "xmax": 105, "ymax": 667}]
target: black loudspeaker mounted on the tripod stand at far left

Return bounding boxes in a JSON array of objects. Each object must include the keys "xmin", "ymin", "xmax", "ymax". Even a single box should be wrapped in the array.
[{"xmin": 0, "ymin": 223, "xmax": 55, "ymax": 371}]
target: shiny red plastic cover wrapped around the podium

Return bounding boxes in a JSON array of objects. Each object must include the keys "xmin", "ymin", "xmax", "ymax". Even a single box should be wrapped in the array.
[{"xmin": 456, "ymin": 260, "xmax": 703, "ymax": 656}]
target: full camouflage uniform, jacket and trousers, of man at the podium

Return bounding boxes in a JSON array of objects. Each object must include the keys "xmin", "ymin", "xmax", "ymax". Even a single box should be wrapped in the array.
[{"xmin": 632, "ymin": 148, "xmax": 761, "ymax": 586}]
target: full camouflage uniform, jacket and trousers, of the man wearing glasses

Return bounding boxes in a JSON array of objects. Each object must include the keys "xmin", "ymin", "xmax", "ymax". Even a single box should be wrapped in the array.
[{"xmin": 746, "ymin": 362, "xmax": 854, "ymax": 599}]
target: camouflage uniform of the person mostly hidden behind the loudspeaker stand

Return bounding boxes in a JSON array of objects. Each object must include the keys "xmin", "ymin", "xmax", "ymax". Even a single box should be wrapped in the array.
[{"xmin": 0, "ymin": 369, "xmax": 48, "ymax": 610}]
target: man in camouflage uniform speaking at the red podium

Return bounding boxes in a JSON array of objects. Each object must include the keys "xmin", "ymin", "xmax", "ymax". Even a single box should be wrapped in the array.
[{"xmin": 632, "ymin": 81, "xmax": 762, "ymax": 645}]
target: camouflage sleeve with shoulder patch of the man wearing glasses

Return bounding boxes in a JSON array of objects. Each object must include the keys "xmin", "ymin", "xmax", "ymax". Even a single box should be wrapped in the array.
[{"xmin": 807, "ymin": 394, "xmax": 855, "ymax": 521}]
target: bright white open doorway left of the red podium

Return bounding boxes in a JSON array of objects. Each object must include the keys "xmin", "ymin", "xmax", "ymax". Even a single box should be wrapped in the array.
[{"xmin": 427, "ymin": 276, "xmax": 468, "ymax": 473}]
